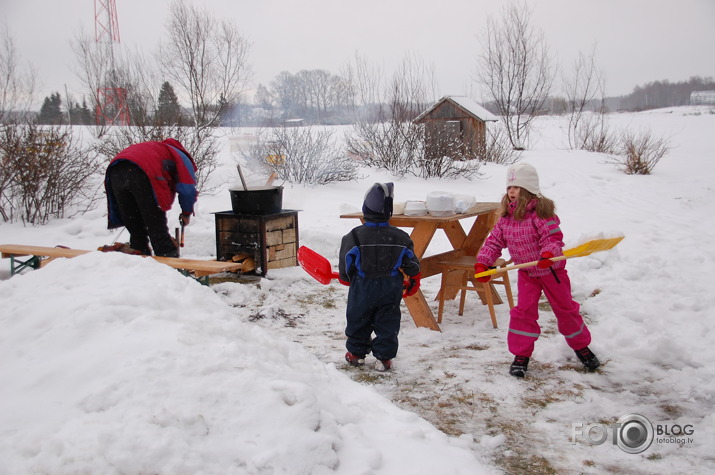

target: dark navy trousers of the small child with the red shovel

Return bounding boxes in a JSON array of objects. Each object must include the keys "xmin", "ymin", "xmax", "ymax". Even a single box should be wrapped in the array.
[{"xmin": 345, "ymin": 275, "xmax": 402, "ymax": 360}]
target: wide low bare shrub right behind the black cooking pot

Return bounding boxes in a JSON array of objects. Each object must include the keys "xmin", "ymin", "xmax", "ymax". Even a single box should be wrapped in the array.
[{"xmin": 239, "ymin": 127, "xmax": 358, "ymax": 185}]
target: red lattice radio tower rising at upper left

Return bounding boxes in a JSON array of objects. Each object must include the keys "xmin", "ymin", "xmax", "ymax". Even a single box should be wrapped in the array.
[{"xmin": 94, "ymin": 0, "xmax": 129, "ymax": 125}]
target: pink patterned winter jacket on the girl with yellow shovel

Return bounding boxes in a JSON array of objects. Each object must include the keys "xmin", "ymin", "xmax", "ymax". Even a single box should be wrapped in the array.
[{"xmin": 477, "ymin": 199, "xmax": 566, "ymax": 277}]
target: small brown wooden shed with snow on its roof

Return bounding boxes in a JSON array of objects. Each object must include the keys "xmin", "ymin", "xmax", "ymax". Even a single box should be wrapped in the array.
[{"xmin": 414, "ymin": 96, "xmax": 499, "ymax": 160}]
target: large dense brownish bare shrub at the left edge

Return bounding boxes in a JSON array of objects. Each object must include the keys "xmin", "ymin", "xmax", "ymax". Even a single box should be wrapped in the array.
[{"xmin": 0, "ymin": 124, "xmax": 99, "ymax": 224}]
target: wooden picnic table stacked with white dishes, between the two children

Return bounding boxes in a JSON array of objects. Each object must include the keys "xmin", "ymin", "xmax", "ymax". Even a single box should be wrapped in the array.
[{"xmin": 340, "ymin": 202, "xmax": 501, "ymax": 331}]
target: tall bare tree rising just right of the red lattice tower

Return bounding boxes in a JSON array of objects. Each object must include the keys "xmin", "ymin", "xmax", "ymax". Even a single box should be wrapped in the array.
[{"xmin": 157, "ymin": 0, "xmax": 251, "ymax": 128}]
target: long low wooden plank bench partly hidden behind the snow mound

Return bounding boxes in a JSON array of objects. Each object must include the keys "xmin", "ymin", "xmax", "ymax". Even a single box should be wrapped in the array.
[{"xmin": 0, "ymin": 244, "xmax": 255, "ymax": 285}]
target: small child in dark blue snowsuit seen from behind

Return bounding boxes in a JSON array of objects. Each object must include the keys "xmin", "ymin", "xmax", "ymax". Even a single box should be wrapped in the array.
[{"xmin": 339, "ymin": 183, "xmax": 420, "ymax": 371}]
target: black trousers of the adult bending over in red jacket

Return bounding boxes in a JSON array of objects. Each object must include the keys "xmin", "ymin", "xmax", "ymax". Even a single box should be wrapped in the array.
[{"xmin": 109, "ymin": 161, "xmax": 179, "ymax": 257}]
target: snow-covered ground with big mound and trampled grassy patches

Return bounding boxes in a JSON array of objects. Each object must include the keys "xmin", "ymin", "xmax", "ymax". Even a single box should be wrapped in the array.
[{"xmin": 0, "ymin": 108, "xmax": 715, "ymax": 474}]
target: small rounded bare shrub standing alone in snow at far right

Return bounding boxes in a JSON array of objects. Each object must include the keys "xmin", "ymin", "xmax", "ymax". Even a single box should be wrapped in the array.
[{"xmin": 615, "ymin": 130, "xmax": 670, "ymax": 175}]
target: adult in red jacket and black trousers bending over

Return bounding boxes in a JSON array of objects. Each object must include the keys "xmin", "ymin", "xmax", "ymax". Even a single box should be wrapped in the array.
[{"xmin": 104, "ymin": 139, "xmax": 197, "ymax": 257}]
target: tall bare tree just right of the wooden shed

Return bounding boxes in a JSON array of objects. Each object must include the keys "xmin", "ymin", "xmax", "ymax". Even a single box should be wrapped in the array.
[{"xmin": 478, "ymin": 2, "xmax": 554, "ymax": 150}]
